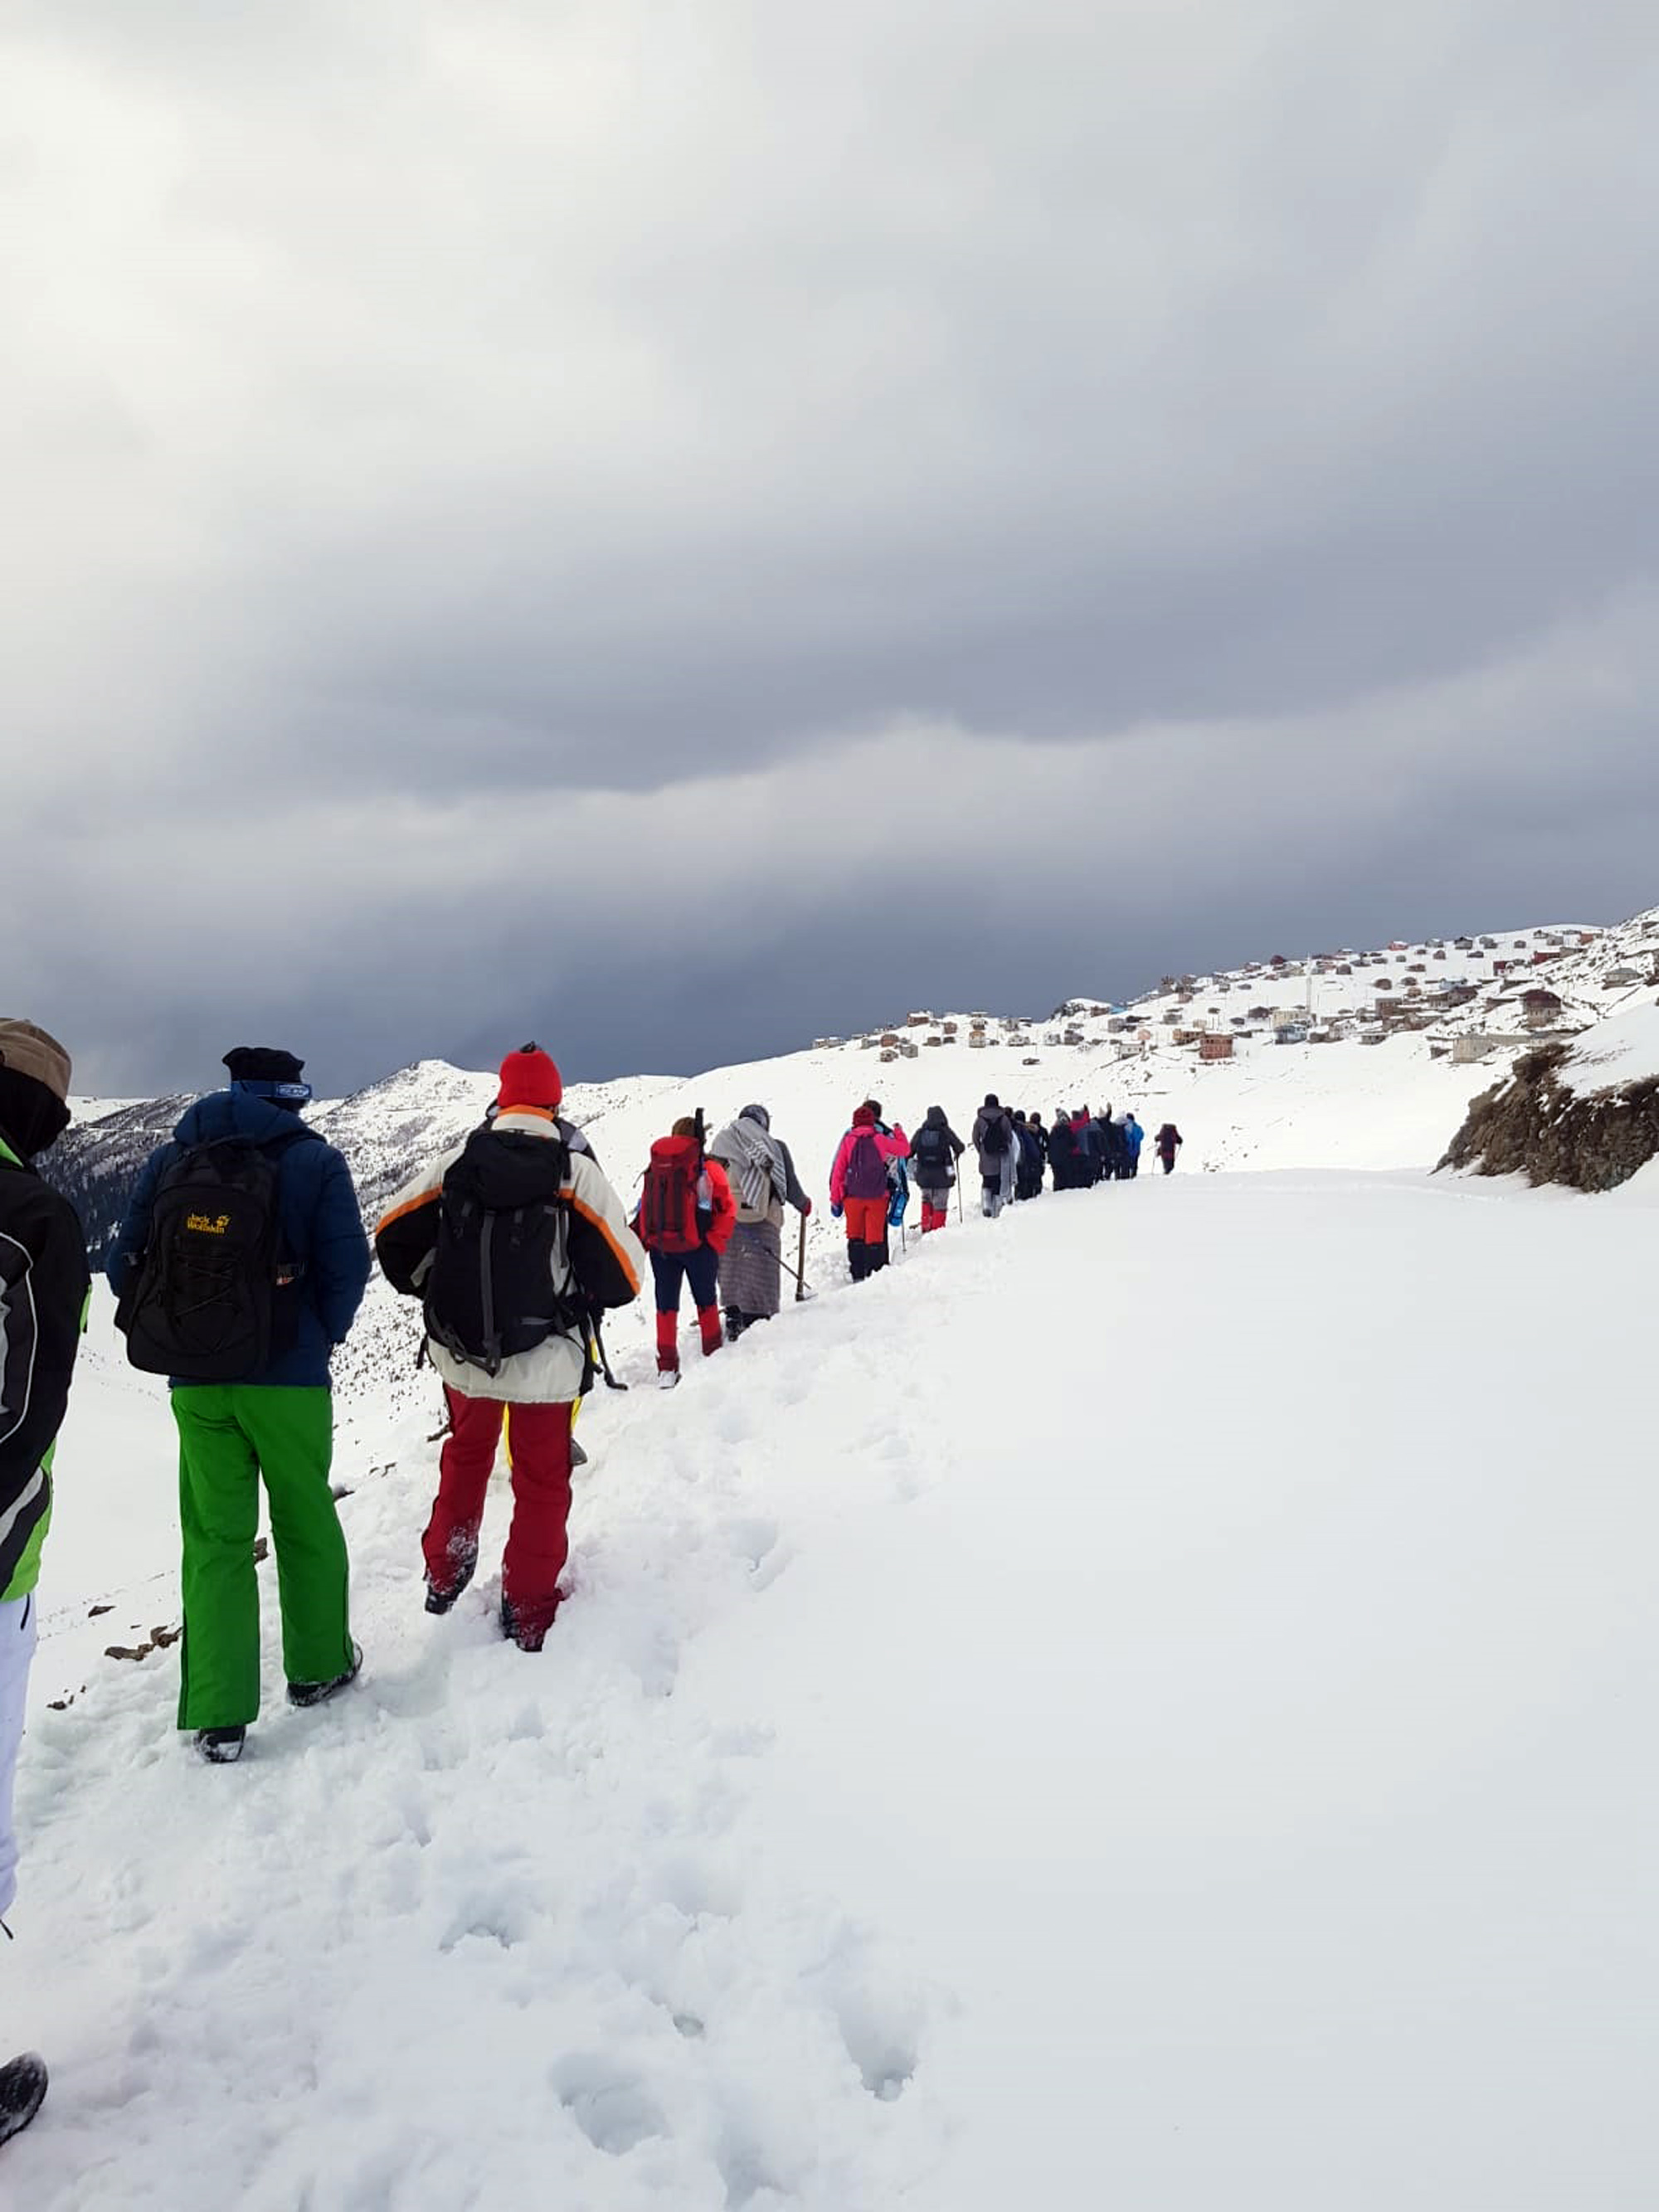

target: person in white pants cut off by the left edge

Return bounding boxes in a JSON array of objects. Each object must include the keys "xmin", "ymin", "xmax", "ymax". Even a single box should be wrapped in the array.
[{"xmin": 0, "ymin": 1018, "xmax": 90, "ymax": 2143}]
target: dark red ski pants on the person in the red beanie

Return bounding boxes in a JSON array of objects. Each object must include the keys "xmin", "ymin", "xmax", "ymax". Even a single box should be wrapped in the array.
[{"xmin": 421, "ymin": 1387, "xmax": 571, "ymax": 1639}]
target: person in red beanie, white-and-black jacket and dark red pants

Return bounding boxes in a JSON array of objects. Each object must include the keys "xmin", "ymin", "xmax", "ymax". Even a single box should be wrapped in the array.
[{"xmin": 374, "ymin": 1044, "xmax": 646, "ymax": 1652}]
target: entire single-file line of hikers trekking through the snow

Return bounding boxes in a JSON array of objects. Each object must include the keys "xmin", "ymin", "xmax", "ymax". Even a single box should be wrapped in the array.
[{"xmin": 0, "ymin": 1019, "xmax": 1181, "ymax": 2142}]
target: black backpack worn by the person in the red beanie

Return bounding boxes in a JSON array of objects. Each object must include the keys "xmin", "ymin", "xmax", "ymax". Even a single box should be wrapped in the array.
[{"xmin": 427, "ymin": 1128, "xmax": 588, "ymax": 1376}]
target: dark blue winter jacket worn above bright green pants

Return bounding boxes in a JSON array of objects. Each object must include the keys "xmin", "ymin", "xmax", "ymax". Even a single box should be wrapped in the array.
[{"xmin": 106, "ymin": 1091, "xmax": 369, "ymax": 1389}]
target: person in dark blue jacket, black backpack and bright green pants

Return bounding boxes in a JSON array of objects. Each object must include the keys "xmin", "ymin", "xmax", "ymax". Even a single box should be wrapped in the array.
[{"xmin": 109, "ymin": 1044, "xmax": 369, "ymax": 1765}]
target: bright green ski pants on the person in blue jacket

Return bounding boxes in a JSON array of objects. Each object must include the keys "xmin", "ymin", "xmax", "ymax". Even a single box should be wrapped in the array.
[{"xmin": 173, "ymin": 1383, "xmax": 352, "ymax": 1728}]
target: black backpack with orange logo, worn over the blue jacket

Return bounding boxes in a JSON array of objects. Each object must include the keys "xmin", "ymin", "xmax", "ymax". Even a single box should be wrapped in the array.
[{"xmin": 115, "ymin": 1128, "xmax": 321, "ymax": 1383}]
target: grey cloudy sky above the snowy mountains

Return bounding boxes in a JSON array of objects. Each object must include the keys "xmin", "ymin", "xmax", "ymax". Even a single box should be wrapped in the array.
[{"xmin": 0, "ymin": 0, "xmax": 1659, "ymax": 1091}]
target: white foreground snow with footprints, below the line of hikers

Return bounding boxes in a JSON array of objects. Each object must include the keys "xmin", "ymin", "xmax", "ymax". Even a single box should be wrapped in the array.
[{"xmin": 0, "ymin": 1174, "xmax": 1659, "ymax": 2212}]
